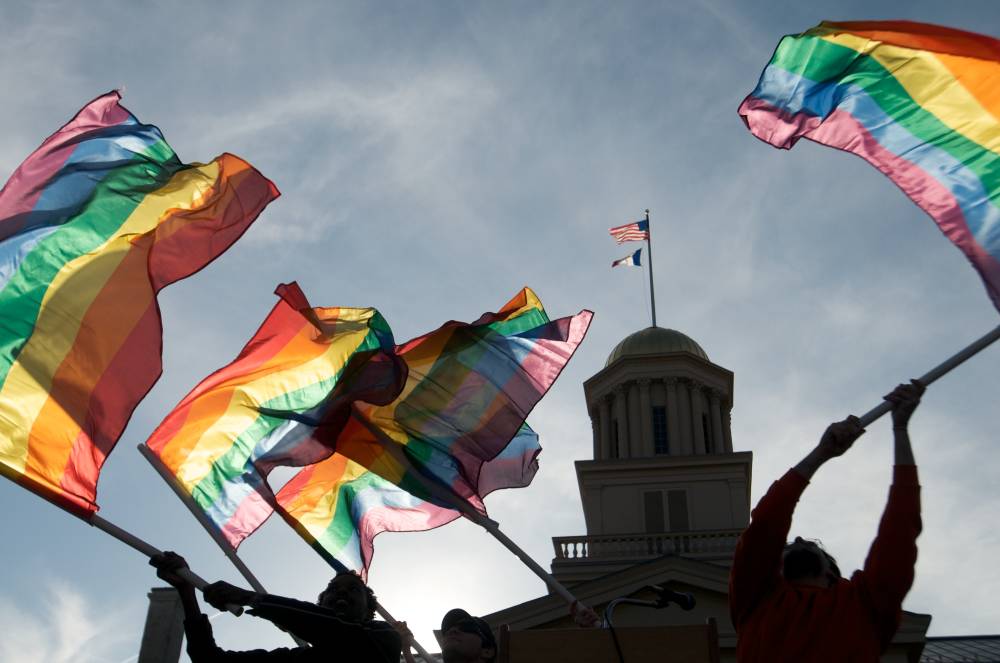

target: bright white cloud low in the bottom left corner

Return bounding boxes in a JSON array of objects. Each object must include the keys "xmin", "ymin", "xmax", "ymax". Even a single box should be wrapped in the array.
[{"xmin": 0, "ymin": 581, "xmax": 134, "ymax": 663}]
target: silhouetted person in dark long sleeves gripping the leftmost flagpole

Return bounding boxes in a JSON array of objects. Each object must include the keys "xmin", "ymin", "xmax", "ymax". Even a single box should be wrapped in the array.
[{"xmin": 149, "ymin": 552, "xmax": 400, "ymax": 663}]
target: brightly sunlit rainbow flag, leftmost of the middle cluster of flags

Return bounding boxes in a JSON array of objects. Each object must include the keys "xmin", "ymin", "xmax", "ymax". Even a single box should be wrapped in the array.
[{"xmin": 146, "ymin": 283, "xmax": 399, "ymax": 548}]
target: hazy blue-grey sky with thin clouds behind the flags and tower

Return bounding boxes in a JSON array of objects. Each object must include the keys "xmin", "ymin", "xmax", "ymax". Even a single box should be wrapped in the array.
[{"xmin": 0, "ymin": 0, "xmax": 1000, "ymax": 663}]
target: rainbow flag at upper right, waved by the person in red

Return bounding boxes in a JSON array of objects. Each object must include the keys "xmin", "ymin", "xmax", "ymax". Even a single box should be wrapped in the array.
[{"xmin": 739, "ymin": 21, "xmax": 1000, "ymax": 308}]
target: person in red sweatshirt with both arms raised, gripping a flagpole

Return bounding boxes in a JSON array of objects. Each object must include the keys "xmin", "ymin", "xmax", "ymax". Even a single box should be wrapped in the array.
[{"xmin": 729, "ymin": 380, "xmax": 924, "ymax": 663}]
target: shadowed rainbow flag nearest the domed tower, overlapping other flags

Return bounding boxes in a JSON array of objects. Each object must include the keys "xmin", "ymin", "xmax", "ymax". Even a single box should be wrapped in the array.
[{"xmin": 348, "ymin": 288, "xmax": 592, "ymax": 515}]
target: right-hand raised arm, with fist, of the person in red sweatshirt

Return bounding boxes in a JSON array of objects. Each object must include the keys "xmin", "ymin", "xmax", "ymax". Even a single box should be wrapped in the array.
[{"xmin": 859, "ymin": 380, "xmax": 924, "ymax": 645}]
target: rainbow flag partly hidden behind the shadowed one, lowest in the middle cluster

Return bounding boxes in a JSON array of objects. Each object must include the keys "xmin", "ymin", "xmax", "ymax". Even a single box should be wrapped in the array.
[{"xmin": 277, "ymin": 424, "xmax": 541, "ymax": 577}]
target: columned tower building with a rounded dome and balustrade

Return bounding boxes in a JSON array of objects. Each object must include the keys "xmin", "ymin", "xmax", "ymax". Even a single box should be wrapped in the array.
[{"xmin": 485, "ymin": 327, "xmax": 936, "ymax": 663}]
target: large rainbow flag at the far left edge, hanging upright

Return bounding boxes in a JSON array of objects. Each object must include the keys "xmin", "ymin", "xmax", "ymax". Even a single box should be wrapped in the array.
[{"xmin": 0, "ymin": 92, "xmax": 279, "ymax": 517}]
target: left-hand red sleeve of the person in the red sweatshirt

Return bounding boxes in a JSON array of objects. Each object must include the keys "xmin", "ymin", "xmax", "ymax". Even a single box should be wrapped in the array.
[{"xmin": 729, "ymin": 470, "xmax": 809, "ymax": 629}]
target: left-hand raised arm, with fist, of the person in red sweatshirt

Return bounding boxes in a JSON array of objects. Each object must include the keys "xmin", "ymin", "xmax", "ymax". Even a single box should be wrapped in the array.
[{"xmin": 729, "ymin": 417, "xmax": 864, "ymax": 628}]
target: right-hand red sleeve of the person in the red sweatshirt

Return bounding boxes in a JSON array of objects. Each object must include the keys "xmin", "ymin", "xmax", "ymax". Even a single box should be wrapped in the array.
[{"xmin": 853, "ymin": 465, "xmax": 921, "ymax": 646}]
